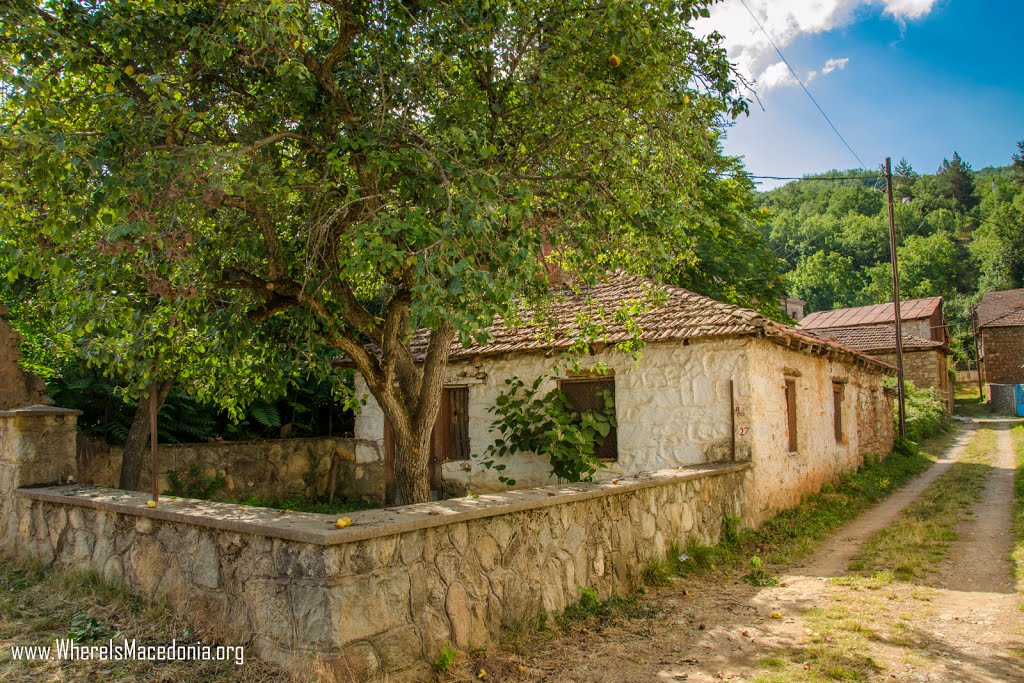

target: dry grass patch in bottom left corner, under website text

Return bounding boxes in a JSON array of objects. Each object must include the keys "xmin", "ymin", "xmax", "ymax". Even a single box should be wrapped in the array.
[{"xmin": 0, "ymin": 563, "xmax": 323, "ymax": 683}]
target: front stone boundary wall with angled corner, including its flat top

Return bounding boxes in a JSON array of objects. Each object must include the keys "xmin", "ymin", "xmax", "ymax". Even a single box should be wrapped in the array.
[{"xmin": 8, "ymin": 463, "xmax": 750, "ymax": 681}]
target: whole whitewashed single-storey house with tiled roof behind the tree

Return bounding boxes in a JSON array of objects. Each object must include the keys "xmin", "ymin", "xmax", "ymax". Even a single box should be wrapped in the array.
[{"xmin": 355, "ymin": 274, "xmax": 893, "ymax": 516}]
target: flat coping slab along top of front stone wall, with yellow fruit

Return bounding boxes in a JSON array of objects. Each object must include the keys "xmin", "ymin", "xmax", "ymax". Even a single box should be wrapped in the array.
[{"xmin": 16, "ymin": 462, "xmax": 751, "ymax": 546}]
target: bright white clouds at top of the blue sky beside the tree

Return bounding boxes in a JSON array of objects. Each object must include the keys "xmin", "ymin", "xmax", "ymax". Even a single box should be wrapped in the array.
[{"xmin": 697, "ymin": 0, "xmax": 938, "ymax": 91}]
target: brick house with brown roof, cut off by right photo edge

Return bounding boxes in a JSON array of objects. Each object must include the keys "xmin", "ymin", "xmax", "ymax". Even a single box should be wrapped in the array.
[{"xmin": 975, "ymin": 289, "xmax": 1024, "ymax": 384}]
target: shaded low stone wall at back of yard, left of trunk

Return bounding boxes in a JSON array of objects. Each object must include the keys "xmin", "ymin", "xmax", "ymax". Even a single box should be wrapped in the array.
[{"xmin": 76, "ymin": 435, "xmax": 384, "ymax": 505}]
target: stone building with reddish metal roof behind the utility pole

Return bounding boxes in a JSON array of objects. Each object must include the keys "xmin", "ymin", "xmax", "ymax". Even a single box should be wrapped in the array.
[{"xmin": 800, "ymin": 297, "xmax": 953, "ymax": 412}]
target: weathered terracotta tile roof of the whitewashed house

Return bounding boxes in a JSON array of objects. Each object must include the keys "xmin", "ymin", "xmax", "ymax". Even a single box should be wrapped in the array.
[{"xmin": 339, "ymin": 273, "xmax": 889, "ymax": 370}]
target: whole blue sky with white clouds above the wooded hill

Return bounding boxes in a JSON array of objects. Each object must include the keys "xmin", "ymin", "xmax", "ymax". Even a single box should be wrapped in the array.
[{"xmin": 697, "ymin": 0, "xmax": 1024, "ymax": 188}]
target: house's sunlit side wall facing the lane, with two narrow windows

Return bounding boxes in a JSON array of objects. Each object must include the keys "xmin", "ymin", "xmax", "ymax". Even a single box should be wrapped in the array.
[{"xmin": 737, "ymin": 339, "xmax": 893, "ymax": 521}]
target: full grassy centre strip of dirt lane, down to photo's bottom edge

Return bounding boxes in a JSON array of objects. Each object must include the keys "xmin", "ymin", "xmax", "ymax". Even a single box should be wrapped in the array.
[{"xmin": 754, "ymin": 428, "xmax": 995, "ymax": 683}]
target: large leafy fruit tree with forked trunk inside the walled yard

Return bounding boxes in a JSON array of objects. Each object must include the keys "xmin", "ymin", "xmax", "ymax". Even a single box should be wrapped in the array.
[{"xmin": 0, "ymin": 0, "xmax": 757, "ymax": 502}]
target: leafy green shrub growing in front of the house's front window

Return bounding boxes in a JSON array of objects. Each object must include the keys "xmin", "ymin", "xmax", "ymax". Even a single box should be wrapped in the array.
[{"xmin": 483, "ymin": 375, "xmax": 616, "ymax": 485}]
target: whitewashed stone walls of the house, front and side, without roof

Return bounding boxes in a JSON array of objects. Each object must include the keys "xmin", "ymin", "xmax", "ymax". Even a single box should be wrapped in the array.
[{"xmin": 355, "ymin": 338, "xmax": 893, "ymax": 519}]
